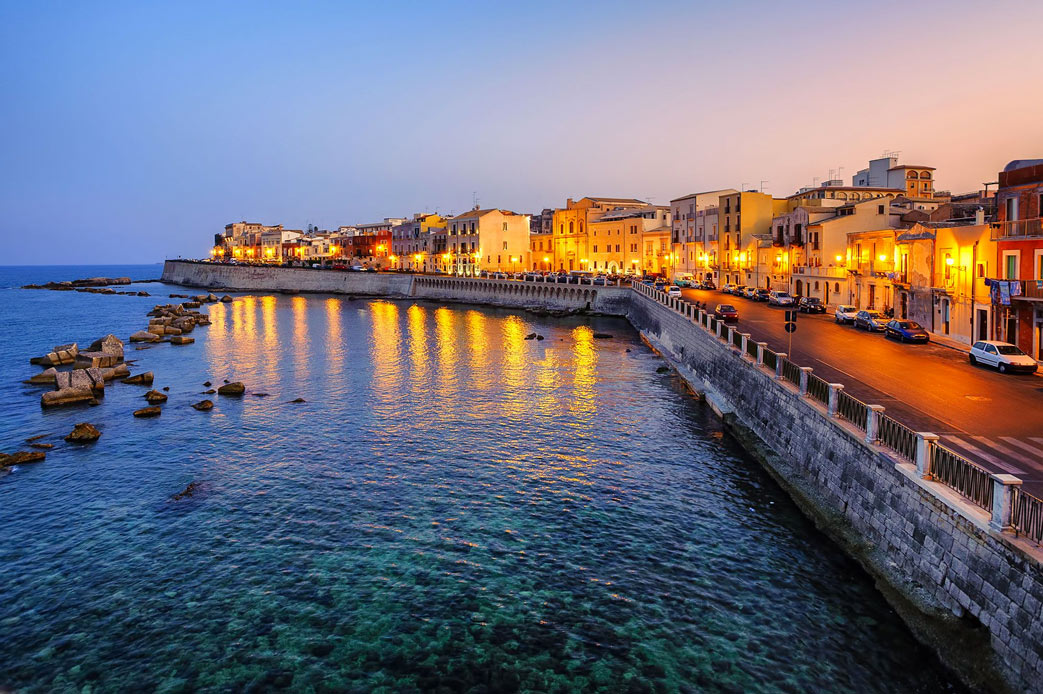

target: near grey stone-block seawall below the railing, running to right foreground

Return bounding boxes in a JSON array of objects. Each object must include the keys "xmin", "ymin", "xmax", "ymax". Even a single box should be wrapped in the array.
[{"xmin": 627, "ymin": 283, "xmax": 1043, "ymax": 692}]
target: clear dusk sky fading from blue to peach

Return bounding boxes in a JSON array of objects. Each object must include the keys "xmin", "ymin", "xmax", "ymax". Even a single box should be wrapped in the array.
[{"xmin": 0, "ymin": 0, "xmax": 1043, "ymax": 265}]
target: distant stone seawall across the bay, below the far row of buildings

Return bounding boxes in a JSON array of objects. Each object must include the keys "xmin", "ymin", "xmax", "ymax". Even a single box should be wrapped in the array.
[{"xmin": 163, "ymin": 260, "xmax": 631, "ymax": 316}]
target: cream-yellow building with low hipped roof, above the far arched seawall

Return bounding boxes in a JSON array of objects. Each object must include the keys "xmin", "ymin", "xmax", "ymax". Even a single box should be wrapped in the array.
[{"xmin": 439, "ymin": 208, "xmax": 531, "ymax": 277}]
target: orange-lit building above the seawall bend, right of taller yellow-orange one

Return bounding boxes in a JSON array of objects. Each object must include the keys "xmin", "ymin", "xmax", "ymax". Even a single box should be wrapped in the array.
[{"xmin": 592, "ymin": 205, "xmax": 671, "ymax": 274}]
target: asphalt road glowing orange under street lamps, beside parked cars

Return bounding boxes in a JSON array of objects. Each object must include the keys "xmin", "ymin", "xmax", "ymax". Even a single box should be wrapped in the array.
[{"xmin": 682, "ymin": 289, "xmax": 1043, "ymax": 498}]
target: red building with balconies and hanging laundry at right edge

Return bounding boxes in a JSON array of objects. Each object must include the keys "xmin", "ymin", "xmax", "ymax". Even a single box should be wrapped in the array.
[{"xmin": 991, "ymin": 159, "xmax": 1043, "ymax": 361}]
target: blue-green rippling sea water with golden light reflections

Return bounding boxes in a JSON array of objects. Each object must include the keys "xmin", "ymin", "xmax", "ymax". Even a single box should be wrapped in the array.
[{"xmin": 0, "ymin": 266, "xmax": 960, "ymax": 692}]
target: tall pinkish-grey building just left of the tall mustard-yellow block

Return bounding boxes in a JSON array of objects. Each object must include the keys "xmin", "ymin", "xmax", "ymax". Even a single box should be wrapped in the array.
[{"xmin": 670, "ymin": 188, "xmax": 738, "ymax": 280}]
